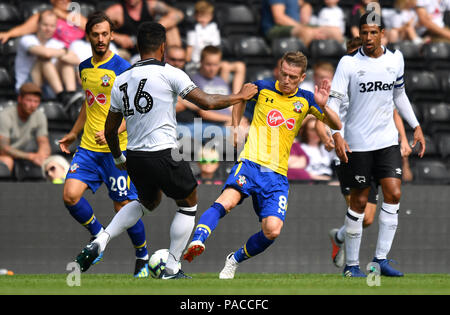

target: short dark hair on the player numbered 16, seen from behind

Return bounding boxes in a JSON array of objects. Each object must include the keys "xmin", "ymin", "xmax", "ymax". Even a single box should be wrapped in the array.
[{"xmin": 137, "ymin": 22, "xmax": 166, "ymax": 54}]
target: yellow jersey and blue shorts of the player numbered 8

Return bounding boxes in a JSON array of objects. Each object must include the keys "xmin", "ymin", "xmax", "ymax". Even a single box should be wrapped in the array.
[{"xmin": 224, "ymin": 80, "xmax": 324, "ymax": 220}]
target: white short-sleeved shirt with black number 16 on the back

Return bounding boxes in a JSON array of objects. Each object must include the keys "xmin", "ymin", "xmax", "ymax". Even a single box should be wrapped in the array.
[{"xmin": 109, "ymin": 59, "xmax": 197, "ymax": 152}]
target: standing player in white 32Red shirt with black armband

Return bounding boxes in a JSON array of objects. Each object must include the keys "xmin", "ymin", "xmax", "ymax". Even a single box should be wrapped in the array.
[{"xmin": 329, "ymin": 11, "xmax": 425, "ymax": 277}]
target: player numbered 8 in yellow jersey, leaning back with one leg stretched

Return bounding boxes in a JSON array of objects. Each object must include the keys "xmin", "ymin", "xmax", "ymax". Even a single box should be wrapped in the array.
[{"xmin": 184, "ymin": 52, "xmax": 341, "ymax": 279}]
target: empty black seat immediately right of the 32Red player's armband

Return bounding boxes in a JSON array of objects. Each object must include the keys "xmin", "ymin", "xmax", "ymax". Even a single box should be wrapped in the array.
[{"xmin": 405, "ymin": 71, "xmax": 444, "ymax": 102}]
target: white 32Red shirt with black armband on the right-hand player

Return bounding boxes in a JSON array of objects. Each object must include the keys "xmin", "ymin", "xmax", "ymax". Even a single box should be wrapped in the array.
[{"xmin": 330, "ymin": 47, "xmax": 418, "ymax": 152}]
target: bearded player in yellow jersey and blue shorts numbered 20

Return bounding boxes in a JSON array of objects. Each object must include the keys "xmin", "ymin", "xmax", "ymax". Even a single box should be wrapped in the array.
[{"xmin": 59, "ymin": 12, "xmax": 149, "ymax": 277}]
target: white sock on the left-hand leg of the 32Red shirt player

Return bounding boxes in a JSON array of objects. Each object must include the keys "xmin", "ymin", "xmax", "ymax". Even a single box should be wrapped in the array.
[{"xmin": 345, "ymin": 208, "xmax": 364, "ymax": 266}]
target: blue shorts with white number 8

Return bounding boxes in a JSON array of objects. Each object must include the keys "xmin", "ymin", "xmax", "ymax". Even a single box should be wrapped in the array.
[{"xmin": 223, "ymin": 160, "xmax": 289, "ymax": 221}]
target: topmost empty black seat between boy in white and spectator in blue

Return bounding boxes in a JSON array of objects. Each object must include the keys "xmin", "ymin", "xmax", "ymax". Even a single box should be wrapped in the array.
[{"xmin": 216, "ymin": 4, "xmax": 259, "ymax": 36}]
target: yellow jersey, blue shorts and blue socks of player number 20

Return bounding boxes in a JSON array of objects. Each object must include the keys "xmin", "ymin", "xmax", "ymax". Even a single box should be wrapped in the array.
[{"xmin": 66, "ymin": 53, "xmax": 148, "ymax": 270}]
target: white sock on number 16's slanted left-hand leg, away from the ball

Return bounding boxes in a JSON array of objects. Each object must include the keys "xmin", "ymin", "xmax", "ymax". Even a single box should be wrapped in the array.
[{"xmin": 94, "ymin": 200, "xmax": 147, "ymax": 252}]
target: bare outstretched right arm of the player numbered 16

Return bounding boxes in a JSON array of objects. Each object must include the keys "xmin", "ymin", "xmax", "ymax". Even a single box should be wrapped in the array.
[{"xmin": 186, "ymin": 83, "xmax": 258, "ymax": 110}]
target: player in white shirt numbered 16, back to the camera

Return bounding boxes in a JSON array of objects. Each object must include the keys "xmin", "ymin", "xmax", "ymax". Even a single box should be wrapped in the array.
[{"xmin": 76, "ymin": 22, "xmax": 258, "ymax": 279}]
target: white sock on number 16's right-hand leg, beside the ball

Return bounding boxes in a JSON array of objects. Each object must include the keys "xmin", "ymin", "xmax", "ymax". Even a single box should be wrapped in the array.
[{"xmin": 166, "ymin": 205, "xmax": 197, "ymax": 274}]
